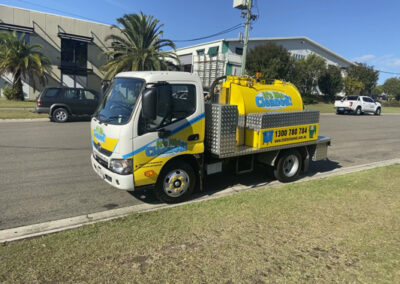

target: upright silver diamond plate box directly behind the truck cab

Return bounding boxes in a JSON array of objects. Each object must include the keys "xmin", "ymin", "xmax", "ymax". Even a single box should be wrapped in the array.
[{"xmin": 205, "ymin": 103, "xmax": 238, "ymax": 155}]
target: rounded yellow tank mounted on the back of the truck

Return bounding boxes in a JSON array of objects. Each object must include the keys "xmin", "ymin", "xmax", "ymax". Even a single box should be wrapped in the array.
[{"xmin": 219, "ymin": 76, "xmax": 303, "ymax": 115}]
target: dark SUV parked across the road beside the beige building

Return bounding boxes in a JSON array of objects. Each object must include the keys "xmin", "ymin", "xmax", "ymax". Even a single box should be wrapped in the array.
[{"xmin": 35, "ymin": 87, "xmax": 100, "ymax": 122}]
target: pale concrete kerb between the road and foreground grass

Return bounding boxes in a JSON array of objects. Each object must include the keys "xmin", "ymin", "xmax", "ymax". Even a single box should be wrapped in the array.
[{"xmin": 0, "ymin": 158, "xmax": 400, "ymax": 243}]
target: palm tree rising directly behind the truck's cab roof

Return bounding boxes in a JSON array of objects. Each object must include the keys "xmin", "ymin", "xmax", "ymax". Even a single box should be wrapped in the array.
[{"xmin": 101, "ymin": 12, "xmax": 179, "ymax": 80}]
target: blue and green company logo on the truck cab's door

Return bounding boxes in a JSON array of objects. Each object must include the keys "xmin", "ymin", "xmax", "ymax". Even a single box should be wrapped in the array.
[{"xmin": 145, "ymin": 138, "xmax": 187, "ymax": 157}]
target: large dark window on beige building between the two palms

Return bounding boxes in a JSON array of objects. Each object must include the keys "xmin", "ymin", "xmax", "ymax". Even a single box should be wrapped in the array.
[{"xmin": 61, "ymin": 38, "xmax": 88, "ymax": 76}]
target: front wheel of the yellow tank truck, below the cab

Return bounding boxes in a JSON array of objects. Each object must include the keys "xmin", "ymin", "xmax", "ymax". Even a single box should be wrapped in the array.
[{"xmin": 156, "ymin": 161, "xmax": 196, "ymax": 203}]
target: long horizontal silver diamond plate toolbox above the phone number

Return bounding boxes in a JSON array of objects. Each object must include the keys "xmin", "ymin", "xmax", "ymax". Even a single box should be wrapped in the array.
[{"xmin": 246, "ymin": 110, "xmax": 319, "ymax": 130}]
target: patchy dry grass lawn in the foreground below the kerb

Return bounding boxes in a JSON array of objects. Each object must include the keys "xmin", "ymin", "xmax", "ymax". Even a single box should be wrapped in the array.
[{"xmin": 0, "ymin": 165, "xmax": 400, "ymax": 283}]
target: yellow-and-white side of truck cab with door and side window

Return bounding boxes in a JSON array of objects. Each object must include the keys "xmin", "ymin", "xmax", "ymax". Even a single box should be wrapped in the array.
[{"xmin": 133, "ymin": 83, "xmax": 204, "ymax": 186}]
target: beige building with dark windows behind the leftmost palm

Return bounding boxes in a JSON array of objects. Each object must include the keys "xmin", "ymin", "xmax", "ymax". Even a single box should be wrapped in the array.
[{"xmin": 0, "ymin": 5, "xmax": 115, "ymax": 99}]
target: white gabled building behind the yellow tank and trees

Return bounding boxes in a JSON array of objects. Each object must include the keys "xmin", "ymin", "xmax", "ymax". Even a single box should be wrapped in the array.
[{"xmin": 177, "ymin": 37, "xmax": 353, "ymax": 87}]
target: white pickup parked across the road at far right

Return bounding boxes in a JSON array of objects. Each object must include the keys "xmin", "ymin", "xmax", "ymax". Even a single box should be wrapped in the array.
[{"xmin": 334, "ymin": 96, "xmax": 382, "ymax": 115}]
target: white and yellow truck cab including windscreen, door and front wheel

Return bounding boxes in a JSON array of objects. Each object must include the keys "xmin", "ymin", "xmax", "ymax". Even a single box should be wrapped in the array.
[{"xmin": 91, "ymin": 72, "xmax": 205, "ymax": 200}]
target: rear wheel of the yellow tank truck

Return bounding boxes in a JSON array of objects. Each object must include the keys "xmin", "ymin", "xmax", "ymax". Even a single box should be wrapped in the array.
[{"xmin": 274, "ymin": 150, "xmax": 303, "ymax": 182}]
